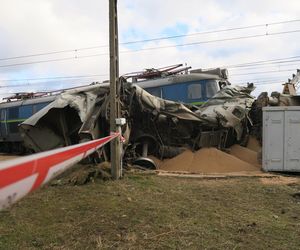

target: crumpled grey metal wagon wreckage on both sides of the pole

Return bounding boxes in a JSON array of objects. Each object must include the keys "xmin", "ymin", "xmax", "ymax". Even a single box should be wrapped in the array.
[{"xmin": 20, "ymin": 83, "xmax": 254, "ymax": 168}]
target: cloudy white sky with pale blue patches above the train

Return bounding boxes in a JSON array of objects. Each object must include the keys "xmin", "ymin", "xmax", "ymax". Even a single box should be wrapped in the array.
[{"xmin": 0, "ymin": 0, "xmax": 300, "ymax": 97}]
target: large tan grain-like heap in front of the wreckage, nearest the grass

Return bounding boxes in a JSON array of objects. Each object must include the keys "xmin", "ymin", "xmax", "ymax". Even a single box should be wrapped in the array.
[{"xmin": 159, "ymin": 148, "xmax": 259, "ymax": 173}]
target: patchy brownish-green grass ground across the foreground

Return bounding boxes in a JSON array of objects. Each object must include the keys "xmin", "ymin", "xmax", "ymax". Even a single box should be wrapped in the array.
[{"xmin": 0, "ymin": 173, "xmax": 300, "ymax": 249}]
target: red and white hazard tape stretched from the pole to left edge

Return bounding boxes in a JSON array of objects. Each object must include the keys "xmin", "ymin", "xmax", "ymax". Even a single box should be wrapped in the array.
[{"xmin": 0, "ymin": 133, "xmax": 119, "ymax": 210}]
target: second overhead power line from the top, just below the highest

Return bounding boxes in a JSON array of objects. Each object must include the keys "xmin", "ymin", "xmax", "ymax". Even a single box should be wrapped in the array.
[{"xmin": 0, "ymin": 30, "xmax": 300, "ymax": 68}]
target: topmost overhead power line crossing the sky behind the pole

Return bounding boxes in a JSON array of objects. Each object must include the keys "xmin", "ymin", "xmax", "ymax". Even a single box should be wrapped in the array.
[{"xmin": 0, "ymin": 19, "xmax": 300, "ymax": 61}]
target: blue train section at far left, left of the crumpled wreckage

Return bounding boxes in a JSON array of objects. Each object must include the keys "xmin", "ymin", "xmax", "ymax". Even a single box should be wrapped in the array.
[{"xmin": 0, "ymin": 94, "xmax": 55, "ymax": 153}]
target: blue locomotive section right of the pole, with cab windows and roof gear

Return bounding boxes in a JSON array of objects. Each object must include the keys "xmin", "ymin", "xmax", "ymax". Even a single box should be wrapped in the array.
[{"xmin": 125, "ymin": 64, "xmax": 230, "ymax": 105}]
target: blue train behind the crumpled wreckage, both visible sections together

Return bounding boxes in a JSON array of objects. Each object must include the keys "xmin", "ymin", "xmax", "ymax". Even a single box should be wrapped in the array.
[{"xmin": 0, "ymin": 64, "xmax": 229, "ymax": 152}]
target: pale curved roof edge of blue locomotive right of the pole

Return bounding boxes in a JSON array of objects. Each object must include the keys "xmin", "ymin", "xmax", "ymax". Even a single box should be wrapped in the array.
[{"xmin": 135, "ymin": 73, "xmax": 226, "ymax": 88}]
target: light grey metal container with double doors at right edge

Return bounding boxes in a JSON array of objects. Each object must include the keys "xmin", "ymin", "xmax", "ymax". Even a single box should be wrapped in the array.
[{"xmin": 262, "ymin": 106, "xmax": 300, "ymax": 172}]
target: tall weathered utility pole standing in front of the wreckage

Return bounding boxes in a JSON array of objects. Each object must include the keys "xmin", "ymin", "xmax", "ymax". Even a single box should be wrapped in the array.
[{"xmin": 109, "ymin": 0, "xmax": 122, "ymax": 180}]
